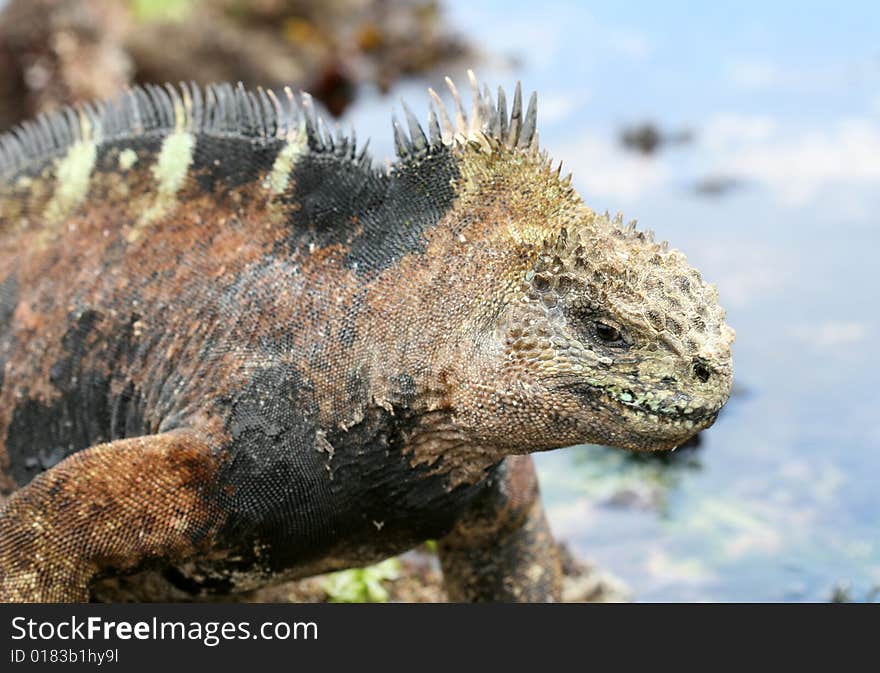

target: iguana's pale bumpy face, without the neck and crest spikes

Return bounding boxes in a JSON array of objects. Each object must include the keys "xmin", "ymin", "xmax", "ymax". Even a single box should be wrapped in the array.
[{"xmin": 497, "ymin": 201, "xmax": 733, "ymax": 449}]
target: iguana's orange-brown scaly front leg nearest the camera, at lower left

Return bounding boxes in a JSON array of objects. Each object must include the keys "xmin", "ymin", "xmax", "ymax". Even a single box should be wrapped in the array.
[{"xmin": 0, "ymin": 430, "xmax": 222, "ymax": 602}]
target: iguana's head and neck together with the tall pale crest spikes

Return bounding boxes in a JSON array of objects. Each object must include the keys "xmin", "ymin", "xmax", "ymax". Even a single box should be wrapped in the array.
[{"xmin": 398, "ymin": 72, "xmax": 734, "ymax": 450}]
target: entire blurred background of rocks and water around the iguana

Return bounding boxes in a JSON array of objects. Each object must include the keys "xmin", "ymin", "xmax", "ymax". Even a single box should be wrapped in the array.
[{"xmin": 0, "ymin": 0, "xmax": 880, "ymax": 601}]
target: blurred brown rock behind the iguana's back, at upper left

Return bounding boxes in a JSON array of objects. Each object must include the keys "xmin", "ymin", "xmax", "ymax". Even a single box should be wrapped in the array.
[{"xmin": 0, "ymin": 0, "xmax": 473, "ymax": 129}]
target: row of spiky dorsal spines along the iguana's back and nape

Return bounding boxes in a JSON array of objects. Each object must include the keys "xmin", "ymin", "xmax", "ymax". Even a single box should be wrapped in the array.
[{"xmin": 0, "ymin": 71, "xmax": 538, "ymax": 181}]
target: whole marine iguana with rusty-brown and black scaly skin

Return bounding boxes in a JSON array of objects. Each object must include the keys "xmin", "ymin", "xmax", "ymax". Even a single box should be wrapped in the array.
[{"xmin": 0, "ymin": 75, "xmax": 733, "ymax": 601}]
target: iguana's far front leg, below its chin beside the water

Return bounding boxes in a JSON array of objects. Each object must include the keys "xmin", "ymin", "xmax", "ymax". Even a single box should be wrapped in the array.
[{"xmin": 439, "ymin": 456, "xmax": 562, "ymax": 602}]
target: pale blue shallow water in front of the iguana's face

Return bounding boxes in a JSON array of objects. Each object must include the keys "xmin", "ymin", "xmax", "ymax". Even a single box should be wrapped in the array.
[{"xmin": 347, "ymin": 0, "xmax": 880, "ymax": 601}]
